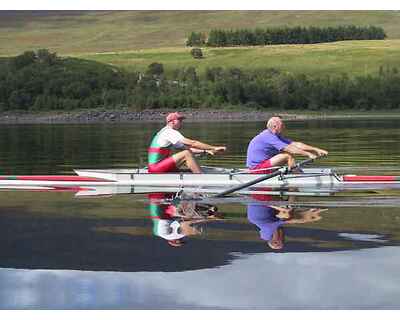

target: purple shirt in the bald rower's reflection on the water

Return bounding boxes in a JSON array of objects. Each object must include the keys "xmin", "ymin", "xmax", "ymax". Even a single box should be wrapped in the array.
[{"xmin": 247, "ymin": 204, "xmax": 286, "ymax": 241}]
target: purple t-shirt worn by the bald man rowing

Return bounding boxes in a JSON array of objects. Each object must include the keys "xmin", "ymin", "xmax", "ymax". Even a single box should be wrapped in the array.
[{"xmin": 246, "ymin": 129, "xmax": 292, "ymax": 168}]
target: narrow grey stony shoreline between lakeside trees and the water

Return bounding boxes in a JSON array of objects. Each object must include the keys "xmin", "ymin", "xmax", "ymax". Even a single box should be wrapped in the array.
[{"xmin": 0, "ymin": 109, "xmax": 399, "ymax": 124}]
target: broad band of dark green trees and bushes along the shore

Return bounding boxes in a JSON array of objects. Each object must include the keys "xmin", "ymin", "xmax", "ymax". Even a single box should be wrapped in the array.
[{"xmin": 0, "ymin": 50, "xmax": 400, "ymax": 111}]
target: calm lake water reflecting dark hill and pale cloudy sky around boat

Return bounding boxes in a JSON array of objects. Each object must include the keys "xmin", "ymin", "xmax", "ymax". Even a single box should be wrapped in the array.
[{"xmin": 0, "ymin": 119, "xmax": 400, "ymax": 309}]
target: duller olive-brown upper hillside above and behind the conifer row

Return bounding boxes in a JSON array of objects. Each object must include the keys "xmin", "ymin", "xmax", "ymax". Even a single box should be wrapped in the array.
[{"xmin": 0, "ymin": 11, "xmax": 400, "ymax": 55}]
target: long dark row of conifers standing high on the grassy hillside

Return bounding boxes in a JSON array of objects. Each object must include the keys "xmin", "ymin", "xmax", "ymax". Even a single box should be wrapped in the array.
[{"xmin": 186, "ymin": 25, "xmax": 386, "ymax": 47}]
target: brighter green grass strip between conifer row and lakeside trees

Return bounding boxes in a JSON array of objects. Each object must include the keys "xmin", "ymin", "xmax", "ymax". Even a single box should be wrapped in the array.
[{"xmin": 77, "ymin": 40, "xmax": 400, "ymax": 75}]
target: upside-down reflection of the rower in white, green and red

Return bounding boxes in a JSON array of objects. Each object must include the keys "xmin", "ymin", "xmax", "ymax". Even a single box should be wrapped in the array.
[{"xmin": 148, "ymin": 193, "xmax": 223, "ymax": 247}]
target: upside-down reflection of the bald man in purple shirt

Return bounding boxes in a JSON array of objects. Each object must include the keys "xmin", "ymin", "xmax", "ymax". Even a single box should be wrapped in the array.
[{"xmin": 247, "ymin": 203, "xmax": 327, "ymax": 250}]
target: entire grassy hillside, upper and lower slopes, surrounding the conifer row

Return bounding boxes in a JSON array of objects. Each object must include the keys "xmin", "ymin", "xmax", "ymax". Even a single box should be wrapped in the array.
[{"xmin": 0, "ymin": 11, "xmax": 400, "ymax": 75}]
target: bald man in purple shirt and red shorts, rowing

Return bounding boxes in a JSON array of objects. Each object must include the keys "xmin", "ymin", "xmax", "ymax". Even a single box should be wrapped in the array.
[{"xmin": 246, "ymin": 117, "xmax": 328, "ymax": 173}]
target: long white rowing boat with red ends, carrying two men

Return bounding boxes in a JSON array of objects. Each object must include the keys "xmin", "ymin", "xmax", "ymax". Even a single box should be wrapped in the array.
[{"xmin": 0, "ymin": 167, "xmax": 400, "ymax": 194}]
